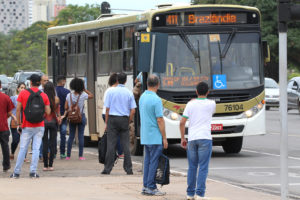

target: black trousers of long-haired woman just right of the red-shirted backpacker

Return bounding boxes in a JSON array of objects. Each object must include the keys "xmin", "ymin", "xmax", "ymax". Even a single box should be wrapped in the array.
[{"xmin": 43, "ymin": 127, "xmax": 57, "ymax": 167}]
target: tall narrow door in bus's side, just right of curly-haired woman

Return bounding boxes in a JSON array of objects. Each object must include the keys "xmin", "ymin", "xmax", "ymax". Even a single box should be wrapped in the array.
[{"xmin": 86, "ymin": 37, "xmax": 98, "ymax": 141}]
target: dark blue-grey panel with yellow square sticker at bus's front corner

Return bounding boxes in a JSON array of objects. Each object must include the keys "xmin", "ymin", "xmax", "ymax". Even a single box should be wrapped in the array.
[{"xmin": 138, "ymin": 32, "xmax": 168, "ymax": 73}]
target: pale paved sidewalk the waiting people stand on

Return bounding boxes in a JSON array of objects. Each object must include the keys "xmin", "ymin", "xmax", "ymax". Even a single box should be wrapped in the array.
[{"xmin": 0, "ymin": 148, "xmax": 280, "ymax": 200}]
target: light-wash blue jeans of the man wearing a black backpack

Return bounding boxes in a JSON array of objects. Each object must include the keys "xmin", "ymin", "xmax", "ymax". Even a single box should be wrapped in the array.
[{"xmin": 14, "ymin": 127, "xmax": 44, "ymax": 174}]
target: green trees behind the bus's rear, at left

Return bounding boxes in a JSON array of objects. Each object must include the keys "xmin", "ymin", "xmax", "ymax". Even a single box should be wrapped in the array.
[{"xmin": 0, "ymin": 5, "xmax": 100, "ymax": 76}]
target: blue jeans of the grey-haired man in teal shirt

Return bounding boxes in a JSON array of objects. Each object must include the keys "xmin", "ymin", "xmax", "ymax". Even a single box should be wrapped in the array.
[{"xmin": 143, "ymin": 144, "xmax": 163, "ymax": 190}]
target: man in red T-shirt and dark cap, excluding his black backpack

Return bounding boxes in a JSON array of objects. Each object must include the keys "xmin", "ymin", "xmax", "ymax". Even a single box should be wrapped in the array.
[{"xmin": 10, "ymin": 74, "xmax": 51, "ymax": 178}]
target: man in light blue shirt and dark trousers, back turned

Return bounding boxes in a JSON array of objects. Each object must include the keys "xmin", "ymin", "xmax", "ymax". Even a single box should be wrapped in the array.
[{"xmin": 101, "ymin": 73, "xmax": 136, "ymax": 175}]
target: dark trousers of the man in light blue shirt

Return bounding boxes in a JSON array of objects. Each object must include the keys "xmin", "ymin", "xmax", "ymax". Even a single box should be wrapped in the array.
[{"xmin": 104, "ymin": 115, "xmax": 132, "ymax": 172}]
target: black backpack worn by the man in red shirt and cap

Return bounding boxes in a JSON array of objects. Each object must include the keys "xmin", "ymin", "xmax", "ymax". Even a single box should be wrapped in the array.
[{"xmin": 24, "ymin": 89, "xmax": 45, "ymax": 123}]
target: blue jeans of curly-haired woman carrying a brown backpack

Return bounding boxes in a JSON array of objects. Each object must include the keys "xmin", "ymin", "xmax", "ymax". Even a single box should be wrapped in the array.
[{"xmin": 67, "ymin": 114, "xmax": 86, "ymax": 157}]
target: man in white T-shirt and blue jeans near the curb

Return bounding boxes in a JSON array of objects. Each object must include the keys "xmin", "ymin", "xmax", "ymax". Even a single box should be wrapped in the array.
[{"xmin": 180, "ymin": 82, "xmax": 216, "ymax": 199}]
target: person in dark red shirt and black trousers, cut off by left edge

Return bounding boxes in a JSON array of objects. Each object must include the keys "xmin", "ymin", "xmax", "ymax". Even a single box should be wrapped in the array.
[{"xmin": 0, "ymin": 81, "xmax": 15, "ymax": 172}]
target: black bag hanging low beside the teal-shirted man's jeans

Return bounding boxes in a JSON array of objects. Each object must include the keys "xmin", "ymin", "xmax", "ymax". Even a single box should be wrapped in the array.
[{"xmin": 155, "ymin": 154, "xmax": 170, "ymax": 186}]
